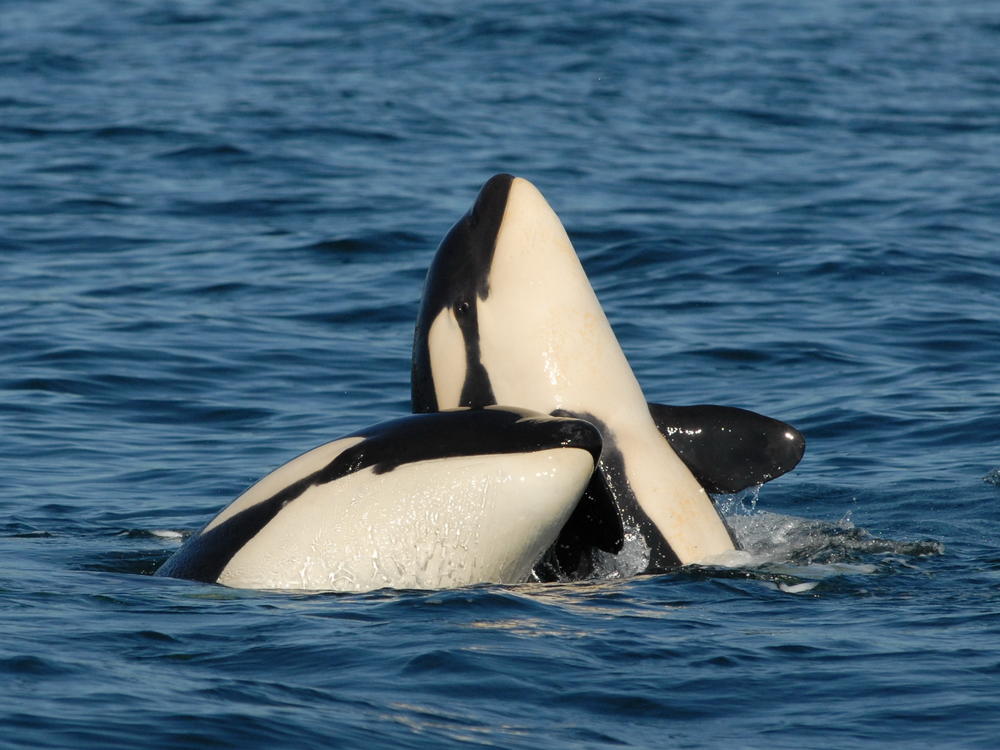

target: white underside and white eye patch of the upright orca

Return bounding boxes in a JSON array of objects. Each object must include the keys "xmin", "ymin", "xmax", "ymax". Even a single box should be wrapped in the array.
[{"xmin": 428, "ymin": 178, "xmax": 734, "ymax": 564}]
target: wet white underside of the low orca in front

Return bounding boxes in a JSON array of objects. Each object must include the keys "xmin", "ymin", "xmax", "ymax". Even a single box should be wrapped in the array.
[{"xmin": 218, "ymin": 449, "xmax": 593, "ymax": 591}]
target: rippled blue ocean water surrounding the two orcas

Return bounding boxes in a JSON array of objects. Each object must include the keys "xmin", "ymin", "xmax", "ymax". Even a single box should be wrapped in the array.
[{"xmin": 0, "ymin": 0, "xmax": 1000, "ymax": 749}]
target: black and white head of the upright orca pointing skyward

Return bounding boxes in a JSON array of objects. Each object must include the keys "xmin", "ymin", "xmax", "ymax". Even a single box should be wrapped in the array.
[{"xmin": 411, "ymin": 174, "xmax": 596, "ymax": 413}]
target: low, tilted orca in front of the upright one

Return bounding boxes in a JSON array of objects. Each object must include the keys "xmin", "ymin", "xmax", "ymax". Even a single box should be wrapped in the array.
[{"xmin": 157, "ymin": 406, "xmax": 602, "ymax": 592}]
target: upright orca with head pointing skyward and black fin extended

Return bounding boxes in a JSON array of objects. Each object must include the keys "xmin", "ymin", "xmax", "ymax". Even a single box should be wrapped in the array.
[{"xmin": 411, "ymin": 174, "xmax": 805, "ymax": 577}]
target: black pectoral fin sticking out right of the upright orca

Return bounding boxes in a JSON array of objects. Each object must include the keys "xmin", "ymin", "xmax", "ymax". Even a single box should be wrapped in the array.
[{"xmin": 649, "ymin": 403, "xmax": 806, "ymax": 494}]
